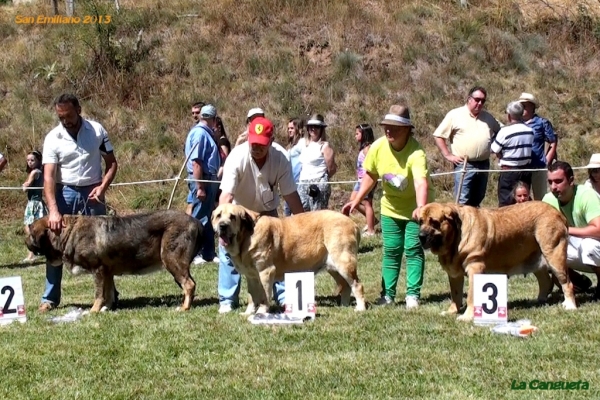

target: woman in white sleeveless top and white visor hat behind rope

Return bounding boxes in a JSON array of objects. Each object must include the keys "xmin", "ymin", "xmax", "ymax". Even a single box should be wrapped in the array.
[{"xmin": 296, "ymin": 114, "xmax": 337, "ymax": 211}]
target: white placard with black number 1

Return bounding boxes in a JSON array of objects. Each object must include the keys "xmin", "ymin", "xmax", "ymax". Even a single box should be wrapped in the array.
[{"xmin": 284, "ymin": 272, "xmax": 317, "ymax": 318}]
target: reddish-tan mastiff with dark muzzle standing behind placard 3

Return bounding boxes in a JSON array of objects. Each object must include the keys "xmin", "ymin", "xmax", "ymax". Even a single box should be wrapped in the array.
[{"xmin": 419, "ymin": 201, "xmax": 577, "ymax": 321}]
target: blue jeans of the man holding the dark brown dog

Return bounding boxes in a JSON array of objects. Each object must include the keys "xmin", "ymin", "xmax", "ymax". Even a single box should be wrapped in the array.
[{"xmin": 42, "ymin": 184, "xmax": 106, "ymax": 306}]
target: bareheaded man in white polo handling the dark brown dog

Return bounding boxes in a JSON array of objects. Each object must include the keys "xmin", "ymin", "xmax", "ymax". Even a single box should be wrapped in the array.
[{"xmin": 39, "ymin": 94, "xmax": 117, "ymax": 312}]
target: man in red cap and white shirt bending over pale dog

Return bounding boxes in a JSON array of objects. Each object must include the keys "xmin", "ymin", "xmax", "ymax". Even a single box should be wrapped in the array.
[{"xmin": 217, "ymin": 117, "xmax": 304, "ymax": 313}]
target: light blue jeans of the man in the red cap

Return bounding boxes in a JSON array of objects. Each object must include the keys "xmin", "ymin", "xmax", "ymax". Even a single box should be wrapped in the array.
[{"xmin": 217, "ymin": 245, "xmax": 285, "ymax": 307}]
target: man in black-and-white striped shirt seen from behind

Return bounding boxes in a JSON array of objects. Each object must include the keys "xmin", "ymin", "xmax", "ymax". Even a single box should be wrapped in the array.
[{"xmin": 491, "ymin": 101, "xmax": 533, "ymax": 207}]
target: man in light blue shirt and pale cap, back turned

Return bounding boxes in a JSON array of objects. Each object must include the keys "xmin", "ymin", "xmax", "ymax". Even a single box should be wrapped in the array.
[{"xmin": 185, "ymin": 104, "xmax": 221, "ymax": 265}]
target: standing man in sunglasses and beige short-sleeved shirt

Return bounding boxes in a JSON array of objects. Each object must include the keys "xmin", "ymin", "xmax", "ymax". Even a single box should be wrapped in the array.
[{"xmin": 433, "ymin": 86, "xmax": 500, "ymax": 207}]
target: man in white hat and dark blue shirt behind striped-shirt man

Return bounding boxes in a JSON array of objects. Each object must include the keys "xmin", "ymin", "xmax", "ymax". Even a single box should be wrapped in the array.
[{"xmin": 518, "ymin": 93, "xmax": 557, "ymax": 200}]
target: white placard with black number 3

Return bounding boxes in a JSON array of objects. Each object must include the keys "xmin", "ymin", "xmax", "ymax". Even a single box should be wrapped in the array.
[{"xmin": 473, "ymin": 274, "xmax": 508, "ymax": 325}]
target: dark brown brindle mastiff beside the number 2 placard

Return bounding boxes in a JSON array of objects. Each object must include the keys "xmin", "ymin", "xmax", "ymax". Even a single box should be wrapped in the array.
[{"xmin": 25, "ymin": 210, "xmax": 202, "ymax": 312}]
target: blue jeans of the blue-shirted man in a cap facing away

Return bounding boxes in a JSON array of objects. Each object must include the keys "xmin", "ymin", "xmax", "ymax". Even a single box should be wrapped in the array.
[{"xmin": 188, "ymin": 175, "xmax": 219, "ymax": 261}]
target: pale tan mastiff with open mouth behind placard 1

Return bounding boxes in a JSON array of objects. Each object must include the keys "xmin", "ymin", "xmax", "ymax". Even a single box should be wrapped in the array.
[{"xmin": 212, "ymin": 204, "xmax": 365, "ymax": 314}]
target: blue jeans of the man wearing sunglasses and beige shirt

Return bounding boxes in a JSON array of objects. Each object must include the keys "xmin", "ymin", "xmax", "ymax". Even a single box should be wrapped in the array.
[{"xmin": 454, "ymin": 160, "xmax": 490, "ymax": 207}]
